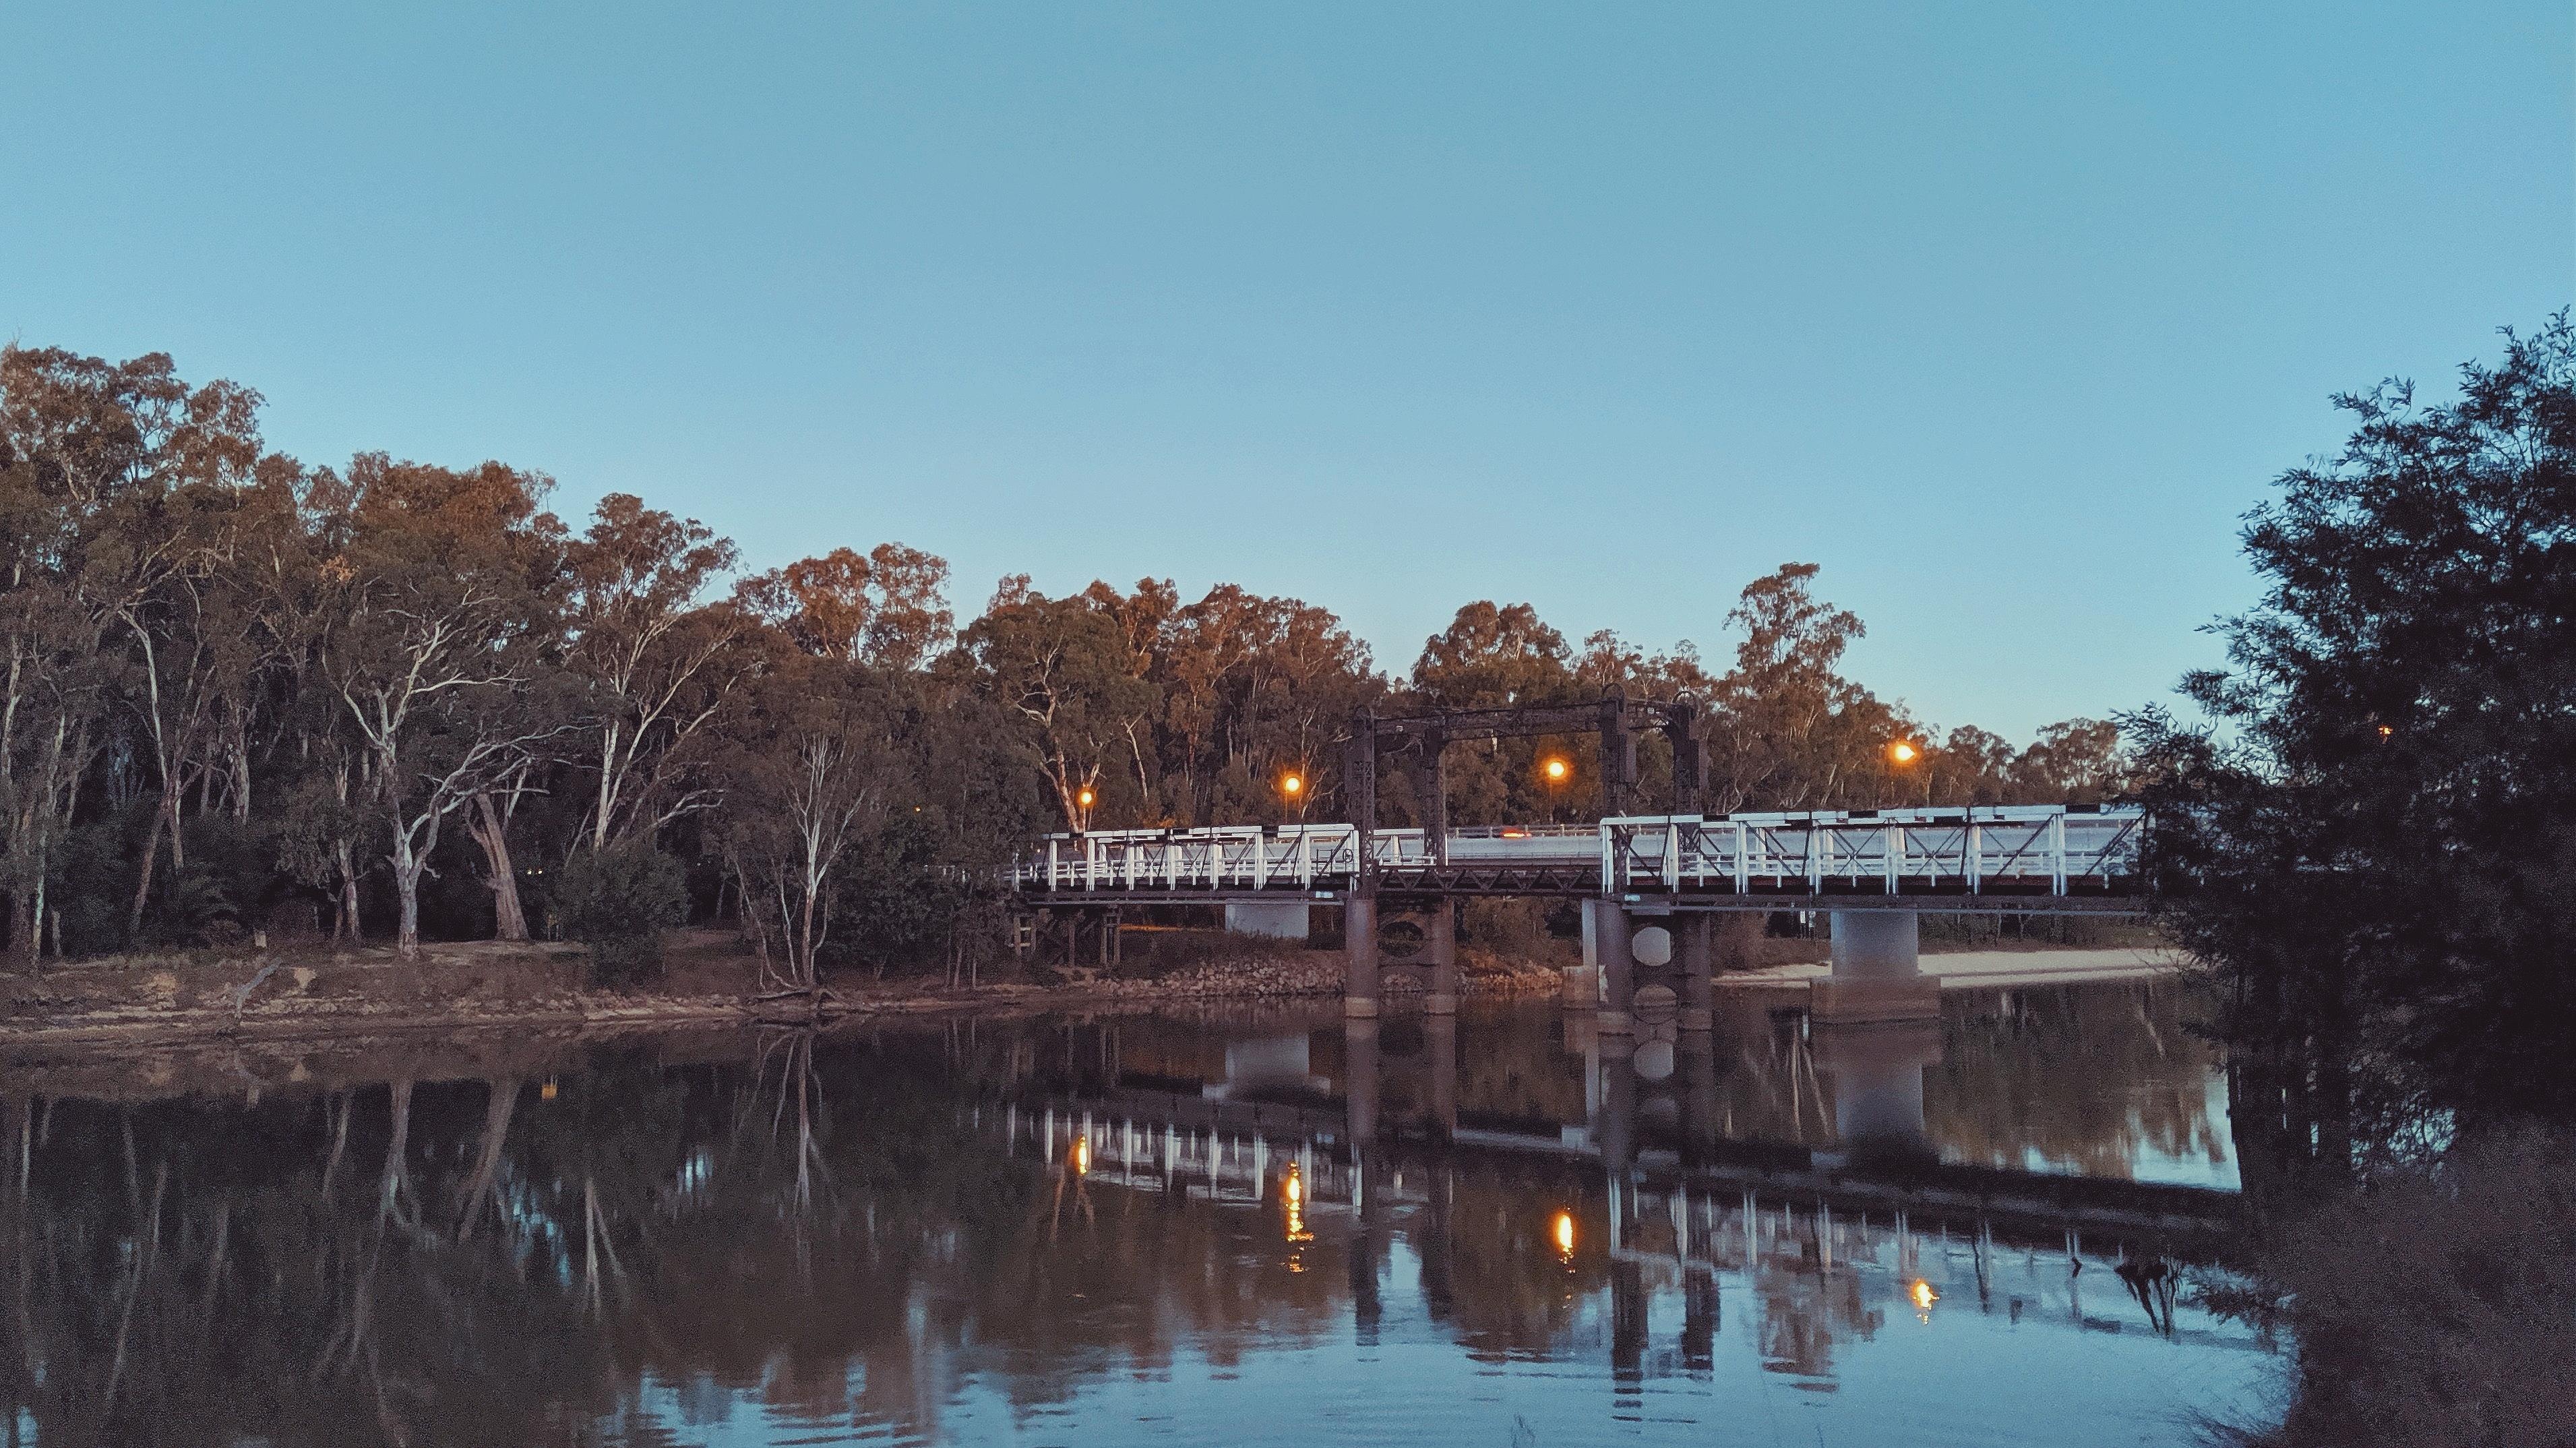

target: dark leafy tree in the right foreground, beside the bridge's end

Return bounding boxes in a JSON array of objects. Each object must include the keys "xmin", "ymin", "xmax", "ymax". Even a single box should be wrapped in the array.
[{"xmin": 2130, "ymin": 314, "xmax": 2576, "ymax": 1113}]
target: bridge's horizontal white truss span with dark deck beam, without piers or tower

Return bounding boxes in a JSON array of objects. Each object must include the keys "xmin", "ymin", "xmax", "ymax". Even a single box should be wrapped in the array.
[{"xmin": 1010, "ymin": 804, "xmax": 2146, "ymax": 912}]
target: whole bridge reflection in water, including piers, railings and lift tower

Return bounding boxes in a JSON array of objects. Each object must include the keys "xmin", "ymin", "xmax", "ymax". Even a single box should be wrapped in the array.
[{"xmin": 987, "ymin": 1018, "xmax": 2262, "ymax": 1376}]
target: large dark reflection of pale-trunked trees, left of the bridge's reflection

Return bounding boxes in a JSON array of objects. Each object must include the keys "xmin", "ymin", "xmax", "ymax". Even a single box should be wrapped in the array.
[{"xmin": 0, "ymin": 1038, "xmax": 1380, "ymax": 1445}]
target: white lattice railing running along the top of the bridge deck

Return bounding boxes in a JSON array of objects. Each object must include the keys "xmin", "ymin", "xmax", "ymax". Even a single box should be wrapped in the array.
[{"xmin": 1010, "ymin": 804, "xmax": 2146, "ymax": 894}]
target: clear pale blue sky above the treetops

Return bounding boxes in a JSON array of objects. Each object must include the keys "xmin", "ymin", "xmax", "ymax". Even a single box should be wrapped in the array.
[{"xmin": 0, "ymin": 0, "xmax": 2576, "ymax": 737}]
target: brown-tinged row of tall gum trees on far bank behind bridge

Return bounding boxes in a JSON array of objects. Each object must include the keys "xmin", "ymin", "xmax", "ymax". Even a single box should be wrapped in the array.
[{"xmin": 0, "ymin": 348, "xmax": 2125, "ymax": 984}]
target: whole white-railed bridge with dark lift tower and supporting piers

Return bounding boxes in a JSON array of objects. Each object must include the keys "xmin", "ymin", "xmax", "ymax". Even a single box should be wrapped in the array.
[{"xmin": 1007, "ymin": 693, "xmax": 2146, "ymax": 1033}]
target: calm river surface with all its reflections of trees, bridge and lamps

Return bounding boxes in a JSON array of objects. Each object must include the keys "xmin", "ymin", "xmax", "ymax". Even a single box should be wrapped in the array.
[{"xmin": 0, "ymin": 984, "xmax": 2282, "ymax": 1448}]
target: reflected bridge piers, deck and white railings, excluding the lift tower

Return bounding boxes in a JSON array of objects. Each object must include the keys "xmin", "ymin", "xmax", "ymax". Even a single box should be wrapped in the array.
[{"xmin": 1000, "ymin": 1018, "xmax": 2238, "ymax": 1270}]
